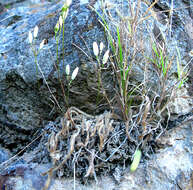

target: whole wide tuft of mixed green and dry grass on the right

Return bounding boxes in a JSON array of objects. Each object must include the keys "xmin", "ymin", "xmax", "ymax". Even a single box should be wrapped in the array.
[{"xmin": 90, "ymin": 0, "xmax": 190, "ymax": 171}]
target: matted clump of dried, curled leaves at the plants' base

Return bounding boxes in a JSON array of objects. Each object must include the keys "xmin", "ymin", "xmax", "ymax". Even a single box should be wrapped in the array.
[{"xmin": 42, "ymin": 103, "xmax": 169, "ymax": 190}]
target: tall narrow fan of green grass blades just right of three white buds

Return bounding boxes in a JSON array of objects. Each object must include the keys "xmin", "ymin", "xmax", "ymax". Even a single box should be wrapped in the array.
[{"xmin": 93, "ymin": 0, "xmax": 146, "ymax": 121}]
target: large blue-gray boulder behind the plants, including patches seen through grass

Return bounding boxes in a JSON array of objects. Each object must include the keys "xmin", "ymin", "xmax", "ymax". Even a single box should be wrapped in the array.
[{"xmin": 0, "ymin": 1, "xmax": 191, "ymax": 130}]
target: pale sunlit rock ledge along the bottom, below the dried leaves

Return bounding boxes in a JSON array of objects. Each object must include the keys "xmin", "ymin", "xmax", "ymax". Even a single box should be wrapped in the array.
[{"xmin": 0, "ymin": 121, "xmax": 193, "ymax": 190}]
